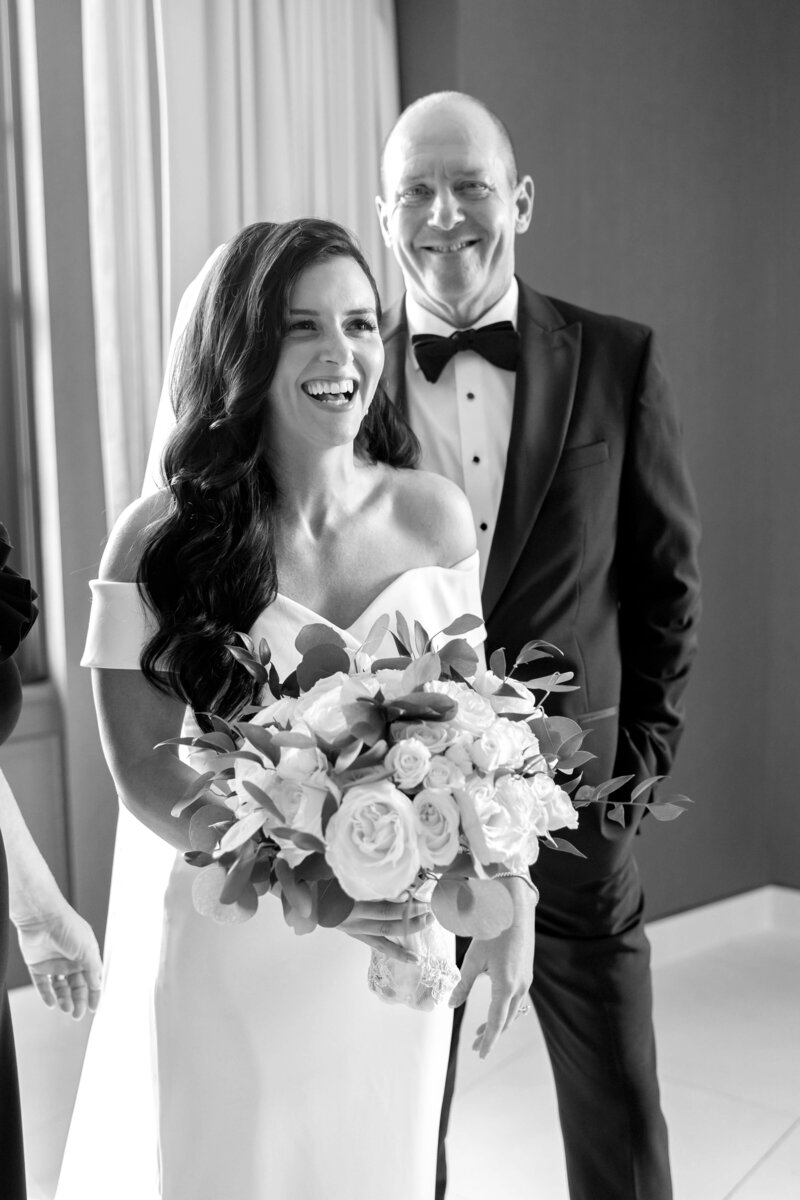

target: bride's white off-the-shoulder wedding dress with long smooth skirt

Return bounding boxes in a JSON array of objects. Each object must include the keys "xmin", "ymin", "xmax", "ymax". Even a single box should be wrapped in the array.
[{"xmin": 56, "ymin": 554, "xmax": 481, "ymax": 1200}]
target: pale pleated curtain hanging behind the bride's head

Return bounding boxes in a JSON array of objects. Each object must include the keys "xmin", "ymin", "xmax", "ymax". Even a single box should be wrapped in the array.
[{"xmin": 83, "ymin": 0, "xmax": 401, "ymax": 523}]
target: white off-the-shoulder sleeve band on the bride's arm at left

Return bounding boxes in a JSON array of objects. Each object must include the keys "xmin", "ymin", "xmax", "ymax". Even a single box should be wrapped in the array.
[{"xmin": 80, "ymin": 580, "xmax": 156, "ymax": 671}]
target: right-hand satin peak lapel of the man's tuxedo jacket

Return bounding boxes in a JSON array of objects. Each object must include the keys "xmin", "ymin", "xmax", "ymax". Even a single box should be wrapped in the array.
[{"xmin": 483, "ymin": 281, "xmax": 581, "ymax": 619}]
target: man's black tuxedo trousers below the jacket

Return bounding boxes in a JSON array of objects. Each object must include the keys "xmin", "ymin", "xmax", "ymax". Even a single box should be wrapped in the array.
[{"xmin": 435, "ymin": 848, "xmax": 672, "ymax": 1200}]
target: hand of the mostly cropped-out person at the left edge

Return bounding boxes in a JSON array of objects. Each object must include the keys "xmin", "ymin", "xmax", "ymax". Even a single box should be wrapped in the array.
[{"xmin": 17, "ymin": 900, "xmax": 103, "ymax": 1020}]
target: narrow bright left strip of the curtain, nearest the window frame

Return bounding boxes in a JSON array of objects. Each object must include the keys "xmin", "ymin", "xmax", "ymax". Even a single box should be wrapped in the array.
[{"xmin": 83, "ymin": 0, "xmax": 163, "ymax": 528}]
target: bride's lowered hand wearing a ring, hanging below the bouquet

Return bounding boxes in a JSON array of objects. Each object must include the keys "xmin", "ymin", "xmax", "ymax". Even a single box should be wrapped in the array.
[{"xmin": 450, "ymin": 878, "xmax": 539, "ymax": 1058}]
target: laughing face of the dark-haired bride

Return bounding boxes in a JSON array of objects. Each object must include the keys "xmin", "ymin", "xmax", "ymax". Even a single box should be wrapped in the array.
[{"xmin": 266, "ymin": 256, "xmax": 384, "ymax": 446}]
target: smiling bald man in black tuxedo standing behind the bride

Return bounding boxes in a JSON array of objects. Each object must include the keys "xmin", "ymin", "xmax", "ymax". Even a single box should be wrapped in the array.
[{"xmin": 377, "ymin": 92, "xmax": 699, "ymax": 1200}]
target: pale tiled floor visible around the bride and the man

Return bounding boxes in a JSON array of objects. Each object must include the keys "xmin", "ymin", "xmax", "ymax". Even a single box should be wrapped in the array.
[{"xmin": 11, "ymin": 888, "xmax": 800, "ymax": 1200}]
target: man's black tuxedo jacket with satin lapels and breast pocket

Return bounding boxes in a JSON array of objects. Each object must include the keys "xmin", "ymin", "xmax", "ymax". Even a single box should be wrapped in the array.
[{"xmin": 381, "ymin": 281, "xmax": 699, "ymax": 874}]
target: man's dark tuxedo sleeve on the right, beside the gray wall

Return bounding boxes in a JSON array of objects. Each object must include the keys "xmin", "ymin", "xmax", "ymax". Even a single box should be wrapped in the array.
[{"xmin": 614, "ymin": 334, "xmax": 700, "ymax": 779}]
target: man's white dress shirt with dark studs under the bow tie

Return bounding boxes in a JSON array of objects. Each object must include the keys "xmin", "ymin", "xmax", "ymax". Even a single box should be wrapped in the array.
[{"xmin": 405, "ymin": 280, "xmax": 519, "ymax": 583}]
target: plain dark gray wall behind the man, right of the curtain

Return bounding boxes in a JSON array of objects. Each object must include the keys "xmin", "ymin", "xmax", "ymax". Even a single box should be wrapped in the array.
[{"xmin": 397, "ymin": 0, "xmax": 800, "ymax": 917}]
